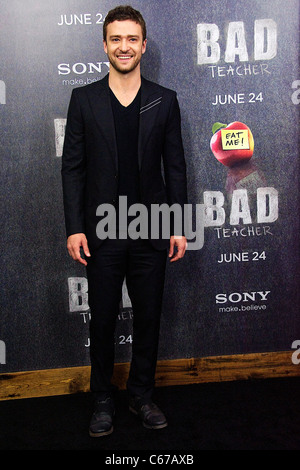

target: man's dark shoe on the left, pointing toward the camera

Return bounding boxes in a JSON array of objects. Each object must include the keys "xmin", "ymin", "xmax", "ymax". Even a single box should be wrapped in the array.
[{"xmin": 89, "ymin": 398, "xmax": 115, "ymax": 437}]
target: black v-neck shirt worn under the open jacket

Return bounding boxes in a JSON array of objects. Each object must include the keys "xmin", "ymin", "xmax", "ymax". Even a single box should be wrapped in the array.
[{"xmin": 110, "ymin": 89, "xmax": 141, "ymax": 207}]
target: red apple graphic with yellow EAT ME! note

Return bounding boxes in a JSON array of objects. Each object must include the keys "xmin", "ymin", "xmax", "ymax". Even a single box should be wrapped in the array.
[{"xmin": 210, "ymin": 121, "xmax": 254, "ymax": 168}]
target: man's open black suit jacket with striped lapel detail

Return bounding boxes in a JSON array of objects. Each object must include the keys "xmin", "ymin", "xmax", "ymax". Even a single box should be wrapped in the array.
[{"xmin": 62, "ymin": 75, "xmax": 187, "ymax": 250}]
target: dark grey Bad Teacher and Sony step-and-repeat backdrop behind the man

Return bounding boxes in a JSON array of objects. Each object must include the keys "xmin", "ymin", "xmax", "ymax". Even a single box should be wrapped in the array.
[{"xmin": 0, "ymin": 0, "xmax": 300, "ymax": 372}]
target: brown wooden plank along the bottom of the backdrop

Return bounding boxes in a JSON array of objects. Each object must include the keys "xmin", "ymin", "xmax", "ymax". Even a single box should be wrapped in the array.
[{"xmin": 0, "ymin": 351, "xmax": 300, "ymax": 400}]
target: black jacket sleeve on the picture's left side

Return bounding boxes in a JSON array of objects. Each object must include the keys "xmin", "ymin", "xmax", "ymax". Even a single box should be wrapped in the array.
[{"xmin": 61, "ymin": 89, "xmax": 86, "ymax": 237}]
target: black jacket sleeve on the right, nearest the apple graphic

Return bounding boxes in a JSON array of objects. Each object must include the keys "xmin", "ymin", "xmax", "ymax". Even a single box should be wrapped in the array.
[{"xmin": 163, "ymin": 93, "xmax": 188, "ymax": 235}]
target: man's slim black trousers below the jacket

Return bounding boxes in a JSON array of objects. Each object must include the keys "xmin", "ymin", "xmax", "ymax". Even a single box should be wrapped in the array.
[{"xmin": 87, "ymin": 239, "xmax": 167, "ymax": 399}]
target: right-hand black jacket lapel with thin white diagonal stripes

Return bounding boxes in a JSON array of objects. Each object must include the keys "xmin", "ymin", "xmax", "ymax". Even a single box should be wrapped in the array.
[{"xmin": 138, "ymin": 78, "xmax": 162, "ymax": 170}]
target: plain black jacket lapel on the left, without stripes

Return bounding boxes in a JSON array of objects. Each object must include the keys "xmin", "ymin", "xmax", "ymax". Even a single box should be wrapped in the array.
[{"xmin": 90, "ymin": 75, "xmax": 118, "ymax": 170}]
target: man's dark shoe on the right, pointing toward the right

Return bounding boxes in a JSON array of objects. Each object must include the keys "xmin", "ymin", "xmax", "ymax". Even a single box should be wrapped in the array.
[{"xmin": 129, "ymin": 397, "xmax": 168, "ymax": 429}]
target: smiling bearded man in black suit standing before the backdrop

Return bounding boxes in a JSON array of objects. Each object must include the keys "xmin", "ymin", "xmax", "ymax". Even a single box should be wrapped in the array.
[{"xmin": 62, "ymin": 6, "xmax": 187, "ymax": 436}]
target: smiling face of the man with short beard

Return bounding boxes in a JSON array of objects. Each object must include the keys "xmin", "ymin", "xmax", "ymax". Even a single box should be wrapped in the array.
[{"xmin": 103, "ymin": 20, "xmax": 147, "ymax": 74}]
